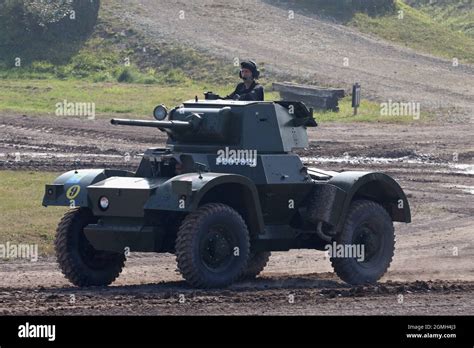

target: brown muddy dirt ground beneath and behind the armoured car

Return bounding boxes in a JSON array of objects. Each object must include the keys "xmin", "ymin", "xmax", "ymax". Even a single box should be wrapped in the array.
[{"xmin": 0, "ymin": 115, "xmax": 474, "ymax": 315}]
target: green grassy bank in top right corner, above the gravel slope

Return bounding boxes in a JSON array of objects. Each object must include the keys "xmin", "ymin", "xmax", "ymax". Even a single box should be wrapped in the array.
[{"xmin": 349, "ymin": 1, "xmax": 474, "ymax": 63}]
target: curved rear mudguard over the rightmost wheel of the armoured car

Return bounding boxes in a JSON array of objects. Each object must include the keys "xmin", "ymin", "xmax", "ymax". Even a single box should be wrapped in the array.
[{"xmin": 327, "ymin": 171, "xmax": 411, "ymax": 228}]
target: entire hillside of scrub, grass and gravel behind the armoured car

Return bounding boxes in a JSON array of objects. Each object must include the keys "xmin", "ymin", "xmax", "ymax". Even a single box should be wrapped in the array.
[{"xmin": 0, "ymin": 0, "xmax": 474, "ymax": 121}]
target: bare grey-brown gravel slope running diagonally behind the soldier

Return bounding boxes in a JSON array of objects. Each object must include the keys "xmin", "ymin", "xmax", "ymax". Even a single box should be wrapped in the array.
[{"xmin": 104, "ymin": 0, "xmax": 474, "ymax": 117}]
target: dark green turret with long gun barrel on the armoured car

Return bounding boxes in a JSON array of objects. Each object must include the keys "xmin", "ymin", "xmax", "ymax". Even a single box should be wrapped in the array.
[{"xmin": 111, "ymin": 100, "xmax": 317, "ymax": 153}]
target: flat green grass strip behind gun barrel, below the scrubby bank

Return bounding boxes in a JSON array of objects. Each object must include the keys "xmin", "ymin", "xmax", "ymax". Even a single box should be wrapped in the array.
[{"xmin": 0, "ymin": 79, "xmax": 277, "ymax": 118}]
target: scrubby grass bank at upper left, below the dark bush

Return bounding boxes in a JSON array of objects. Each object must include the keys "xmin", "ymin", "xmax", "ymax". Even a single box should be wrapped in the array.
[{"xmin": 0, "ymin": 1, "xmax": 233, "ymax": 85}]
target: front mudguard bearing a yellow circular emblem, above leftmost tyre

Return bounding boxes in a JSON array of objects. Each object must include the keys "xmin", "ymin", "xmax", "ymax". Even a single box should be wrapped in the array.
[{"xmin": 43, "ymin": 169, "xmax": 134, "ymax": 207}]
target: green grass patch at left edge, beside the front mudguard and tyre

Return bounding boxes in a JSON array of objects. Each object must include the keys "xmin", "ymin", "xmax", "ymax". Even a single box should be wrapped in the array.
[{"xmin": 0, "ymin": 171, "xmax": 67, "ymax": 255}]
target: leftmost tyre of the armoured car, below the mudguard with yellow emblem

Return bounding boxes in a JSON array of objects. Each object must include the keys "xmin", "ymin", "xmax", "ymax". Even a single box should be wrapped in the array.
[{"xmin": 54, "ymin": 208, "xmax": 125, "ymax": 287}]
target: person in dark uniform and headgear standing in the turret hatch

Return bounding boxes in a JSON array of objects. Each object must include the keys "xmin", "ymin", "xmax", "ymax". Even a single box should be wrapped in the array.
[{"xmin": 222, "ymin": 60, "xmax": 264, "ymax": 101}]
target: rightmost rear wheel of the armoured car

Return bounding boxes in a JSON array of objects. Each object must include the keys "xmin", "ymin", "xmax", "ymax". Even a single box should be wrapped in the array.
[{"xmin": 331, "ymin": 200, "xmax": 395, "ymax": 285}]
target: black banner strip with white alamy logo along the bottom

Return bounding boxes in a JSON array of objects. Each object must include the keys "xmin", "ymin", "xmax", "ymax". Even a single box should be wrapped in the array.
[{"xmin": 0, "ymin": 316, "xmax": 474, "ymax": 348}]
